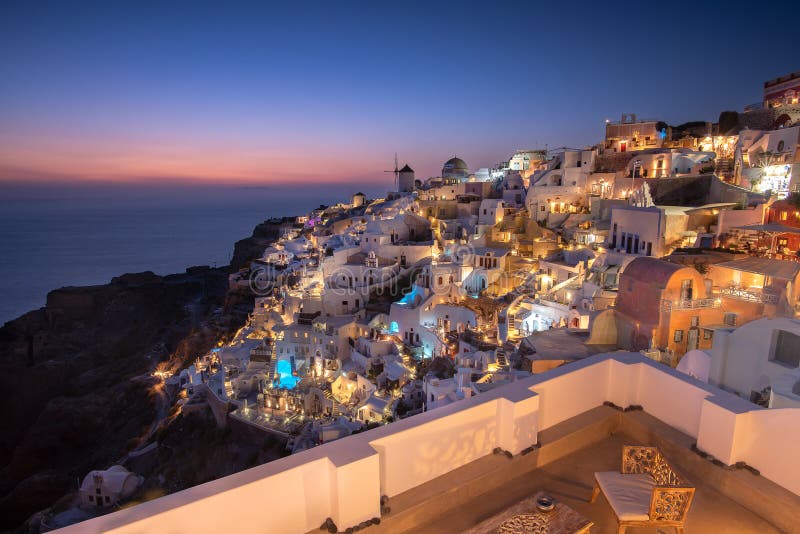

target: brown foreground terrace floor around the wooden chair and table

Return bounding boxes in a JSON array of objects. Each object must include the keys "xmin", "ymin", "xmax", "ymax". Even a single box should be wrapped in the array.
[{"xmin": 369, "ymin": 406, "xmax": 800, "ymax": 534}]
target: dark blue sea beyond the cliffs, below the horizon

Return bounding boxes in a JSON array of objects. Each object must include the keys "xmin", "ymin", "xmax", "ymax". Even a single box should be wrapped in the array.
[{"xmin": 0, "ymin": 184, "xmax": 385, "ymax": 325}]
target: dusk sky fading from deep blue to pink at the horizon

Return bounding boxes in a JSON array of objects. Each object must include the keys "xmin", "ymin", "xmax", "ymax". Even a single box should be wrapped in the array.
[{"xmin": 0, "ymin": 0, "xmax": 800, "ymax": 184}]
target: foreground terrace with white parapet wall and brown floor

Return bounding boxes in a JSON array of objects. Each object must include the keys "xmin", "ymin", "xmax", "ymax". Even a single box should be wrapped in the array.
[{"xmin": 56, "ymin": 353, "xmax": 800, "ymax": 533}]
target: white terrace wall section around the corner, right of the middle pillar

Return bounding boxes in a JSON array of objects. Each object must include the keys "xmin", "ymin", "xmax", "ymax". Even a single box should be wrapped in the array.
[{"xmin": 531, "ymin": 353, "xmax": 800, "ymax": 495}]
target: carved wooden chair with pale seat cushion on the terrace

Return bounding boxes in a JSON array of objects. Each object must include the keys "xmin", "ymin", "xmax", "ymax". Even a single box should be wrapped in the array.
[{"xmin": 589, "ymin": 445, "xmax": 695, "ymax": 534}]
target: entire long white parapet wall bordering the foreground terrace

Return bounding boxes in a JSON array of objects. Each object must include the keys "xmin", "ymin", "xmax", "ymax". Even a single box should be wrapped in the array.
[{"xmin": 57, "ymin": 353, "xmax": 800, "ymax": 533}]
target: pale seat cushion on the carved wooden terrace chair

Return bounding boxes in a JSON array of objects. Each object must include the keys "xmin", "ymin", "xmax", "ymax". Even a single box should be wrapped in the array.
[{"xmin": 594, "ymin": 471, "xmax": 656, "ymax": 521}]
